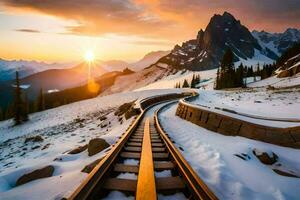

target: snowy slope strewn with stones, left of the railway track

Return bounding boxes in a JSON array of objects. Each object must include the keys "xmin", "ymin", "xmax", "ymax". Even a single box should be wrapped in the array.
[{"xmin": 0, "ymin": 89, "xmax": 181, "ymax": 200}]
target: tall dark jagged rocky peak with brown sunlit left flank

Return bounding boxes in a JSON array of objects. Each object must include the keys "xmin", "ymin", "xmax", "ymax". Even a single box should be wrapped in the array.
[{"xmin": 158, "ymin": 12, "xmax": 296, "ymax": 71}]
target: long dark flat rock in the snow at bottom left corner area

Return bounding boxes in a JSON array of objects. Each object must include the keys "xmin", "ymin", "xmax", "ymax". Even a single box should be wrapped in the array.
[{"xmin": 16, "ymin": 165, "xmax": 54, "ymax": 186}]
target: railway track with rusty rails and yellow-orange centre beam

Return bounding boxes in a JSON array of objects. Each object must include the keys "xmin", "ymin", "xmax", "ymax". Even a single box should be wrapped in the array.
[{"xmin": 69, "ymin": 95, "xmax": 217, "ymax": 200}]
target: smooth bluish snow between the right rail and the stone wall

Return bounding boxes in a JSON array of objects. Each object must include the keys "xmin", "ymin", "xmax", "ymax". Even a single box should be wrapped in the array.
[{"xmin": 159, "ymin": 105, "xmax": 300, "ymax": 200}]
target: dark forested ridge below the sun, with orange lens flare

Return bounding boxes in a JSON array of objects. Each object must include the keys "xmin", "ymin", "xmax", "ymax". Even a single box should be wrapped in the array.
[{"xmin": 0, "ymin": 70, "xmax": 129, "ymax": 124}]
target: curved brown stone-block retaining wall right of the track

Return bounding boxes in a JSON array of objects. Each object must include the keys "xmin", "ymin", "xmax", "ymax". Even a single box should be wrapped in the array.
[{"xmin": 176, "ymin": 99, "xmax": 300, "ymax": 149}]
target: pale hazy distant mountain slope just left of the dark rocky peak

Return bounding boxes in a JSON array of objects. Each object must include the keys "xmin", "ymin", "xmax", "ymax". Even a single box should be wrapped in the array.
[{"xmin": 130, "ymin": 51, "xmax": 170, "ymax": 71}]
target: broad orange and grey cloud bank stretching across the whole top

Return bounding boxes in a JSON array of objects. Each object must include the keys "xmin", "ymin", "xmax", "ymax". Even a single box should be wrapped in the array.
[{"xmin": 2, "ymin": 0, "xmax": 300, "ymax": 40}]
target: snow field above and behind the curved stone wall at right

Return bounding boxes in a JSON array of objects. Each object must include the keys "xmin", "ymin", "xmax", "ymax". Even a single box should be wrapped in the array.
[{"xmin": 191, "ymin": 88, "xmax": 300, "ymax": 127}]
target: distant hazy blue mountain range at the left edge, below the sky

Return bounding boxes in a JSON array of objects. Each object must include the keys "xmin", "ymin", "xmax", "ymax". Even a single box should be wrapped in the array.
[{"xmin": 0, "ymin": 59, "xmax": 72, "ymax": 82}]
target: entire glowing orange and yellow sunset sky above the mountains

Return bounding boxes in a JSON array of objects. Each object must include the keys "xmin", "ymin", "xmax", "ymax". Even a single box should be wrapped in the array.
[{"xmin": 0, "ymin": 0, "xmax": 300, "ymax": 62}]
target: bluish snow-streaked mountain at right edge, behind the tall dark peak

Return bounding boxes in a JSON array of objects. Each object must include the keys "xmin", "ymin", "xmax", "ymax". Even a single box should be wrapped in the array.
[{"xmin": 252, "ymin": 28, "xmax": 300, "ymax": 57}]
